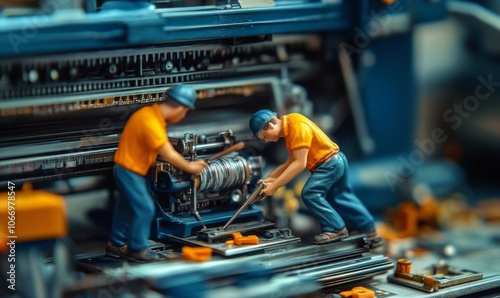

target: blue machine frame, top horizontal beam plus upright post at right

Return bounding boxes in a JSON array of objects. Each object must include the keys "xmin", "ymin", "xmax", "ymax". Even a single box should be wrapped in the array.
[{"xmin": 0, "ymin": 0, "xmax": 445, "ymax": 156}]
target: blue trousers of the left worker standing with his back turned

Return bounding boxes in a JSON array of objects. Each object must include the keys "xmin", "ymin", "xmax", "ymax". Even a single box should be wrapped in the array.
[{"xmin": 110, "ymin": 165, "xmax": 155, "ymax": 251}]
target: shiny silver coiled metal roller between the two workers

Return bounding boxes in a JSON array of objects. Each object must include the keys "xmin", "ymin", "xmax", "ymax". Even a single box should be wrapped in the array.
[{"xmin": 198, "ymin": 156, "xmax": 250, "ymax": 192}]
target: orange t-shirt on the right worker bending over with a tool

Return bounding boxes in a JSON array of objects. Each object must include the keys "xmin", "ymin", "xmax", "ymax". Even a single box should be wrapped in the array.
[{"xmin": 281, "ymin": 113, "xmax": 339, "ymax": 172}]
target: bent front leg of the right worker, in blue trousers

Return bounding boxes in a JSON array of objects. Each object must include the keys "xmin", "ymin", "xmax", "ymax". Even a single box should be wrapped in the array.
[{"xmin": 302, "ymin": 158, "xmax": 345, "ymax": 232}]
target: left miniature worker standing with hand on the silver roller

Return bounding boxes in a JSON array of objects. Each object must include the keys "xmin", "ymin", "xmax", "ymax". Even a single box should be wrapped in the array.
[{"xmin": 106, "ymin": 85, "xmax": 206, "ymax": 262}]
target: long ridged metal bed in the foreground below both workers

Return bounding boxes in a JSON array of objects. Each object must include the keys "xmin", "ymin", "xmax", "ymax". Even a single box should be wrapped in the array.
[{"xmin": 68, "ymin": 236, "xmax": 393, "ymax": 297}]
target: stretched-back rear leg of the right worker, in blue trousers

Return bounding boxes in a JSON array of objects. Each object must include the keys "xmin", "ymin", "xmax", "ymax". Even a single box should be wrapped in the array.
[{"xmin": 327, "ymin": 152, "xmax": 375, "ymax": 232}]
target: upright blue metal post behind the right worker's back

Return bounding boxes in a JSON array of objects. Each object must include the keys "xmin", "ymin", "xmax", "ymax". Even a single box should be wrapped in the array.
[{"xmin": 360, "ymin": 32, "xmax": 418, "ymax": 156}]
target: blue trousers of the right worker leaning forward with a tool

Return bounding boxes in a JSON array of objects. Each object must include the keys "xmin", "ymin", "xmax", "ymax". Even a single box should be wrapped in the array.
[{"xmin": 302, "ymin": 152, "xmax": 375, "ymax": 232}]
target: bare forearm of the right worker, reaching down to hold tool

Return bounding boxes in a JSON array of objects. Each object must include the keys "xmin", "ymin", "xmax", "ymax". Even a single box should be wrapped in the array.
[{"xmin": 262, "ymin": 148, "xmax": 309, "ymax": 196}]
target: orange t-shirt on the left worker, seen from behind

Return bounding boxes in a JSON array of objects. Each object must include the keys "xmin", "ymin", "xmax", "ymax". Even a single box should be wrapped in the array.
[{"xmin": 115, "ymin": 103, "xmax": 168, "ymax": 176}]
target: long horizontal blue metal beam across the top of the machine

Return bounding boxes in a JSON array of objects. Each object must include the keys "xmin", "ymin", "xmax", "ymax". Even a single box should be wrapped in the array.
[{"xmin": 0, "ymin": 1, "xmax": 354, "ymax": 58}]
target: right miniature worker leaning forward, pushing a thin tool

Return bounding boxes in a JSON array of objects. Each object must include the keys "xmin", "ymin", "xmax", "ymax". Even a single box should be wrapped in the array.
[{"xmin": 249, "ymin": 109, "xmax": 380, "ymax": 244}]
